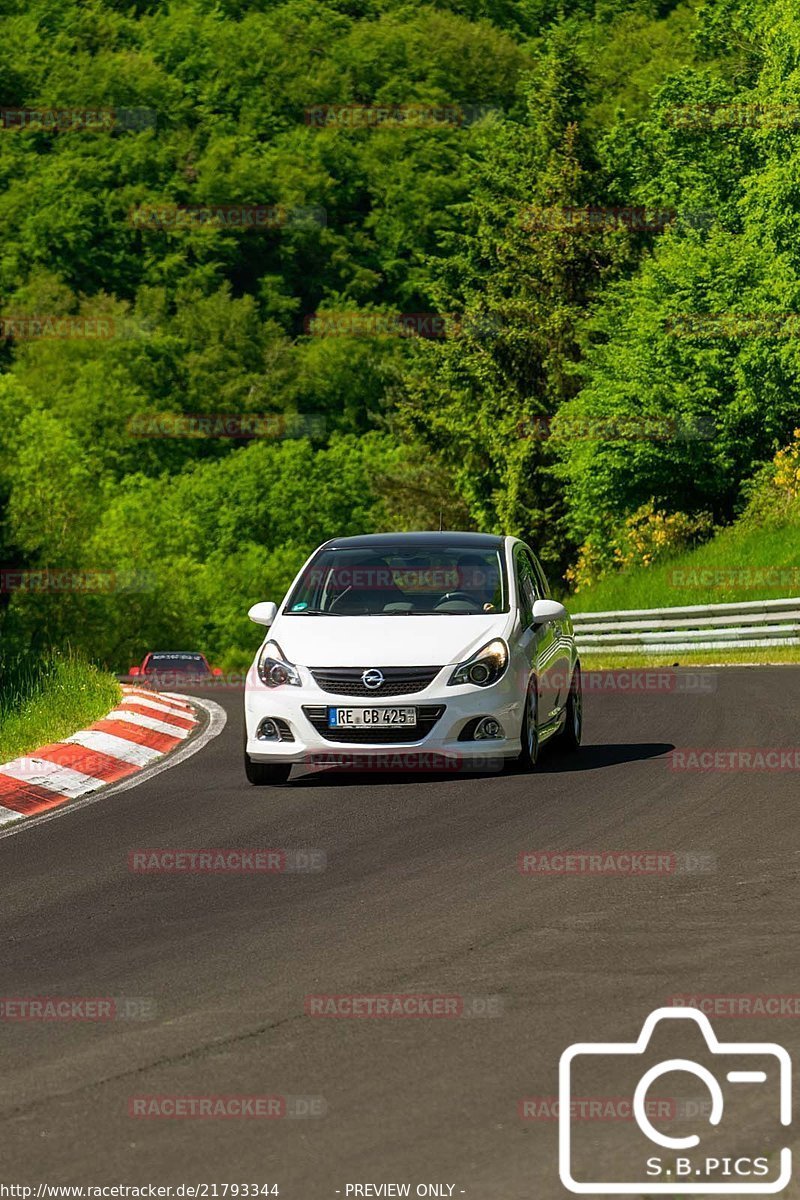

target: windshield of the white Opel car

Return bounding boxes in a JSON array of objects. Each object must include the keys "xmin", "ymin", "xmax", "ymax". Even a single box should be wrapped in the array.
[{"xmin": 283, "ymin": 541, "xmax": 509, "ymax": 617}]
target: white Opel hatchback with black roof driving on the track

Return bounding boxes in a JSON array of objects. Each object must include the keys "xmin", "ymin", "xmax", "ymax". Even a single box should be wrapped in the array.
[{"xmin": 245, "ymin": 533, "xmax": 582, "ymax": 784}]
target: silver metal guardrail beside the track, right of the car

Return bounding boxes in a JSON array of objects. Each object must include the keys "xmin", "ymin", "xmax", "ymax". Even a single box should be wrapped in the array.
[{"xmin": 572, "ymin": 596, "xmax": 800, "ymax": 654}]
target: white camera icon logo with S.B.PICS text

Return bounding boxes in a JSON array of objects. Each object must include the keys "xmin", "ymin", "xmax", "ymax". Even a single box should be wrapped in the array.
[{"xmin": 559, "ymin": 1008, "xmax": 792, "ymax": 1195}]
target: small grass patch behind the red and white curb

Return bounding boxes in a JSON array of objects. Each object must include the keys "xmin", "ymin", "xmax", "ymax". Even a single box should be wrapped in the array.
[{"xmin": 0, "ymin": 654, "xmax": 121, "ymax": 763}]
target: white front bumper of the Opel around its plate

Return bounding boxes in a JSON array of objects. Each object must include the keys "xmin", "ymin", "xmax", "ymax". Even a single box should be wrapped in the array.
[{"xmin": 245, "ymin": 666, "xmax": 525, "ymax": 766}]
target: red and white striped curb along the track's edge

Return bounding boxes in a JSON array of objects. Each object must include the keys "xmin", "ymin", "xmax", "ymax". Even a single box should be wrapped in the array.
[{"xmin": 0, "ymin": 686, "xmax": 209, "ymax": 827}]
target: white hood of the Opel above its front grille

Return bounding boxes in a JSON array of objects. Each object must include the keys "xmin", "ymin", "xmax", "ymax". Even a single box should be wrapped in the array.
[{"xmin": 267, "ymin": 612, "xmax": 510, "ymax": 667}]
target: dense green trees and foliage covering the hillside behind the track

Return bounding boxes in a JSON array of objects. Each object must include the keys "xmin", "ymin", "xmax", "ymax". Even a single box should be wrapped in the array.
[{"xmin": 0, "ymin": 0, "xmax": 800, "ymax": 667}]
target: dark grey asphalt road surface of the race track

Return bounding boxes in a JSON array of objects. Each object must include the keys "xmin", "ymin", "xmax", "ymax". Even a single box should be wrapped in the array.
[{"xmin": 0, "ymin": 667, "xmax": 800, "ymax": 1200}]
